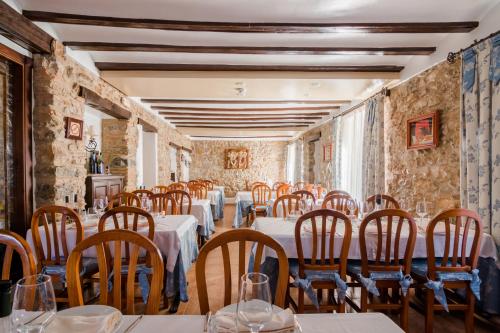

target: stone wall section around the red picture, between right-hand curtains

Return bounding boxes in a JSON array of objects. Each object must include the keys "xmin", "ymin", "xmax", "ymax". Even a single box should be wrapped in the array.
[{"xmin": 384, "ymin": 61, "xmax": 460, "ymax": 211}]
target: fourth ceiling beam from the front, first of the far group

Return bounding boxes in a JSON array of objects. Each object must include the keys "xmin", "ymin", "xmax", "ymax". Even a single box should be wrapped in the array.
[{"xmin": 141, "ymin": 98, "xmax": 351, "ymax": 105}]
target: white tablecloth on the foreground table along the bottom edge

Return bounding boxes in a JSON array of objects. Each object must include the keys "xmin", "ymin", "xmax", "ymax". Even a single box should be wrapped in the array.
[{"xmin": 112, "ymin": 313, "xmax": 403, "ymax": 333}]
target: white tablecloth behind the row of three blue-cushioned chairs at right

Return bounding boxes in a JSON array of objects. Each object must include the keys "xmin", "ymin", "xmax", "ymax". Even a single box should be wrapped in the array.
[{"xmin": 252, "ymin": 217, "xmax": 497, "ymax": 259}]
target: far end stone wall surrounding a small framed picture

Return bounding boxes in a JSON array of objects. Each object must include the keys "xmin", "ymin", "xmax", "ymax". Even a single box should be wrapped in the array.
[{"xmin": 190, "ymin": 140, "xmax": 287, "ymax": 197}]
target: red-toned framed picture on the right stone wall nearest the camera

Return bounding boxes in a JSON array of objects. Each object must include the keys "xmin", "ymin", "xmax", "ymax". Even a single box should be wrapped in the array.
[{"xmin": 406, "ymin": 111, "xmax": 439, "ymax": 149}]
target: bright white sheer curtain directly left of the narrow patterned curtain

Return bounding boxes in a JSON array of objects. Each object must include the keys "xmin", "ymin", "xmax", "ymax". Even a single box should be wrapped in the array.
[{"xmin": 336, "ymin": 107, "xmax": 365, "ymax": 200}]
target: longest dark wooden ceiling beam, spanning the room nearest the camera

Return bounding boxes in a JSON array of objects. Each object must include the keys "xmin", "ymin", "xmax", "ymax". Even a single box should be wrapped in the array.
[{"xmin": 23, "ymin": 10, "xmax": 479, "ymax": 33}]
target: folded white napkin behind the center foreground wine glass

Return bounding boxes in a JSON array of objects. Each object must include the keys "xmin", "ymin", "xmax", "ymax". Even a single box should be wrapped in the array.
[{"xmin": 217, "ymin": 305, "xmax": 295, "ymax": 333}]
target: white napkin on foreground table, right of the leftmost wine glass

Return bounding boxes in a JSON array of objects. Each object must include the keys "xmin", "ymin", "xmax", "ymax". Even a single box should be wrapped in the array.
[{"xmin": 48, "ymin": 310, "xmax": 122, "ymax": 333}]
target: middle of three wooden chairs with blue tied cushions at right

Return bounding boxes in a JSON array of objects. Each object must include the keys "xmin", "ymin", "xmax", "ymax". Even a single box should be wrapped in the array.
[{"xmin": 347, "ymin": 209, "xmax": 417, "ymax": 332}]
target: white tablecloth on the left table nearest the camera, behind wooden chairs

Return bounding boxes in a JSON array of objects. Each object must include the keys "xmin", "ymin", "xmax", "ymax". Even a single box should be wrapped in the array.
[{"xmin": 26, "ymin": 215, "xmax": 197, "ymax": 272}]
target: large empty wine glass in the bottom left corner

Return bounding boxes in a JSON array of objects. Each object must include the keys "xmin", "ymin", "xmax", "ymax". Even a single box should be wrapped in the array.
[{"xmin": 11, "ymin": 274, "xmax": 57, "ymax": 333}]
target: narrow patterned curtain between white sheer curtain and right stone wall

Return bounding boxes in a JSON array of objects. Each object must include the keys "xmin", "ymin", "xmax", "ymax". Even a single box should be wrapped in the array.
[{"xmin": 362, "ymin": 95, "xmax": 385, "ymax": 199}]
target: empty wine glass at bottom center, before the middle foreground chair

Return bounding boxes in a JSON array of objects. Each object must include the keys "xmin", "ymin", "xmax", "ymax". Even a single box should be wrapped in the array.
[{"xmin": 236, "ymin": 273, "xmax": 273, "ymax": 333}]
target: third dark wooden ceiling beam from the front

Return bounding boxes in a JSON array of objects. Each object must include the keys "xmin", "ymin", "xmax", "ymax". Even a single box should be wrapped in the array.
[{"xmin": 95, "ymin": 62, "xmax": 404, "ymax": 73}]
